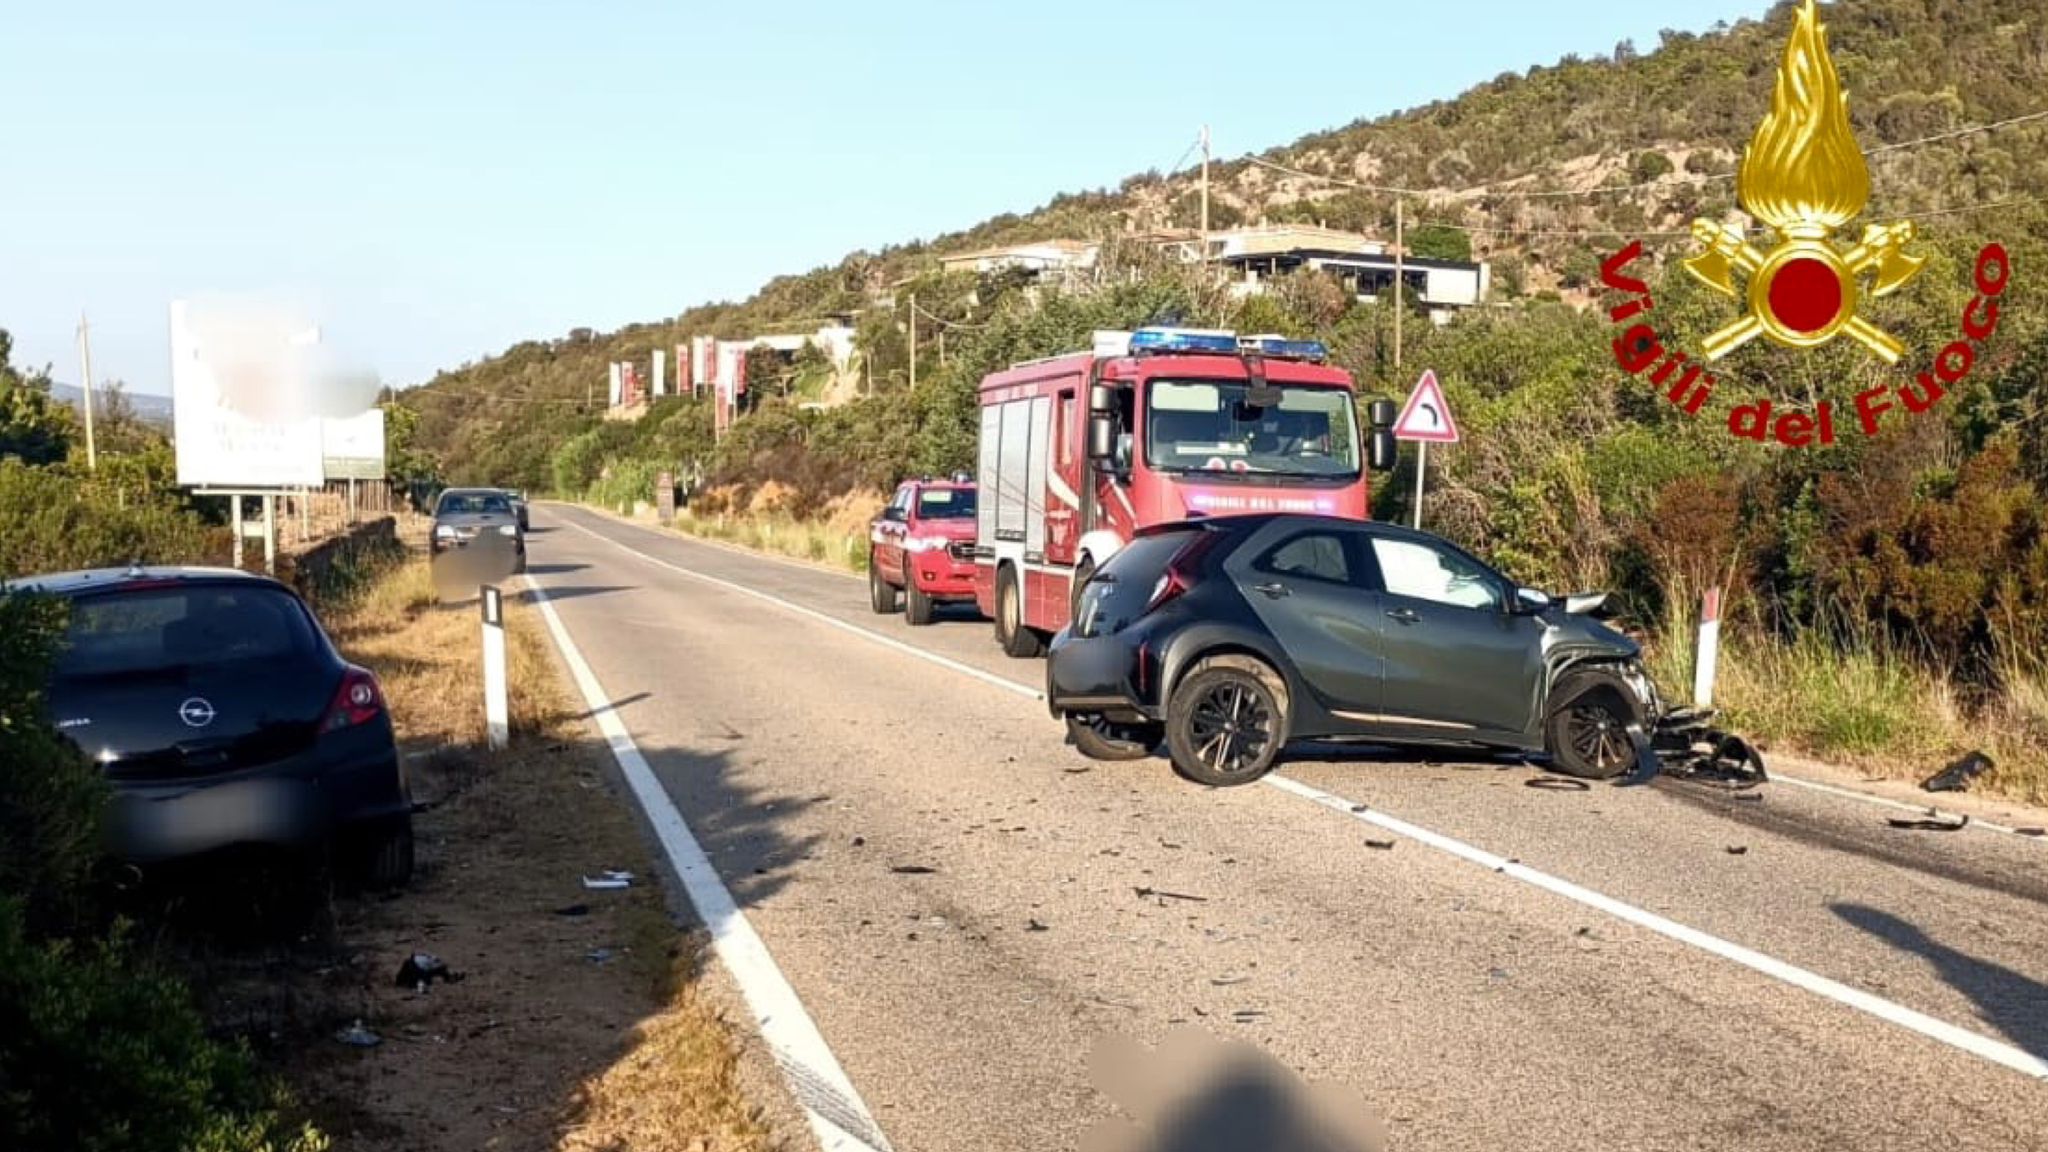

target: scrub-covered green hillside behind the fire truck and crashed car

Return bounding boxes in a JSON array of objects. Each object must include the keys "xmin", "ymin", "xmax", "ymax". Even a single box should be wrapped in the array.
[{"xmin": 399, "ymin": 0, "xmax": 2048, "ymax": 793}]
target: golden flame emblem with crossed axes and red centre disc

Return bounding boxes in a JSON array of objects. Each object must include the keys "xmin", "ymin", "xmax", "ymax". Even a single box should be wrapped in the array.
[{"xmin": 1686, "ymin": 0, "xmax": 1925, "ymax": 363}]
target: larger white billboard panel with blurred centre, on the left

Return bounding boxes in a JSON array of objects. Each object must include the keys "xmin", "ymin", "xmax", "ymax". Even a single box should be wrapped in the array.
[{"xmin": 170, "ymin": 299, "xmax": 324, "ymax": 488}]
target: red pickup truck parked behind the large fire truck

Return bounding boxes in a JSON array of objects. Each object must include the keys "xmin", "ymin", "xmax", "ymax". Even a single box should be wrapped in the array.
[{"xmin": 868, "ymin": 471, "xmax": 975, "ymax": 625}]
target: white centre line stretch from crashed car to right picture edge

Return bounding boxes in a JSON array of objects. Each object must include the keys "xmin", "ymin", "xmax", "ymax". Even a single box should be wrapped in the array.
[{"xmin": 1264, "ymin": 775, "xmax": 2048, "ymax": 1080}]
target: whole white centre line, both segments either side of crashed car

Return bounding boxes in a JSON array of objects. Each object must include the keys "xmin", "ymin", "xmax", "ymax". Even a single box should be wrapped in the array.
[{"xmin": 552, "ymin": 508, "xmax": 2048, "ymax": 1080}]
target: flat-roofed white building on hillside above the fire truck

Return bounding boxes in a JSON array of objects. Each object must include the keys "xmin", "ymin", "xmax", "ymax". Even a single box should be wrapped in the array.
[{"xmin": 1151, "ymin": 223, "xmax": 1493, "ymax": 324}]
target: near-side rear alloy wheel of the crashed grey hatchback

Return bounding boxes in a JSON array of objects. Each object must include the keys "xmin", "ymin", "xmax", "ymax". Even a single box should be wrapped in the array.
[{"xmin": 1165, "ymin": 656, "xmax": 1286, "ymax": 787}]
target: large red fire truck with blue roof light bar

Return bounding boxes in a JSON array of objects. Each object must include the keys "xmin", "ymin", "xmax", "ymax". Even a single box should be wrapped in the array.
[{"xmin": 975, "ymin": 328, "xmax": 1397, "ymax": 656}]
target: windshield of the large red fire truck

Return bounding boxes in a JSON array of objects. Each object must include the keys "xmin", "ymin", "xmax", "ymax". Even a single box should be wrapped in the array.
[{"xmin": 1145, "ymin": 379, "xmax": 1360, "ymax": 478}]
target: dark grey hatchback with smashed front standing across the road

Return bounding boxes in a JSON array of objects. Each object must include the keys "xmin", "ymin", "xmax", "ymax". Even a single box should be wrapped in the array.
[{"xmin": 1047, "ymin": 515, "xmax": 1663, "ymax": 785}]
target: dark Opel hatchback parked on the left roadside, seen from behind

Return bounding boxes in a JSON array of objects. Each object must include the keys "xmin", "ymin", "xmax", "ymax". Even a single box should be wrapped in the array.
[{"xmin": 4, "ymin": 568, "xmax": 414, "ymax": 888}]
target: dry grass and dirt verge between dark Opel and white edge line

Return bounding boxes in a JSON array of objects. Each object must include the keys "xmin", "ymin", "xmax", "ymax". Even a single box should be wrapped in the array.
[{"xmin": 276, "ymin": 560, "xmax": 772, "ymax": 1152}]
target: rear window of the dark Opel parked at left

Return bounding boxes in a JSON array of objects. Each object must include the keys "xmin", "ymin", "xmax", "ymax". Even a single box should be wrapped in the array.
[{"xmin": 57, "ymin": 584, "xmax": 319, "ymax": 678}]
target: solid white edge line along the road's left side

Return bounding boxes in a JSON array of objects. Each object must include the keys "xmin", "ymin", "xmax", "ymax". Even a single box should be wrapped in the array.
[{"xmin": 526, "ymin": 574, "xmax": 891, "ymax": 1152}]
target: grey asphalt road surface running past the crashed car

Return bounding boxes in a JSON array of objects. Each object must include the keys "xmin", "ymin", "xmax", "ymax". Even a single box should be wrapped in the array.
[{"xmin": 530, "ymin": 506, "xmax": 2048, "ymax": 1152}]
